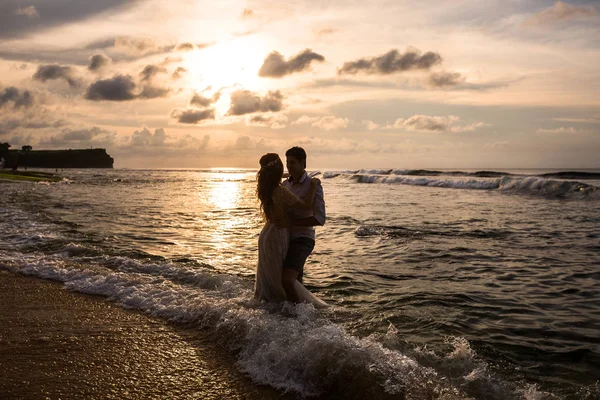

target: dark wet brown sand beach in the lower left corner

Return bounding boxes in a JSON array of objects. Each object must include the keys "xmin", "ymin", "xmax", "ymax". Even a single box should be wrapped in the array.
[{"xmin": 0, "ymin": 271, "xmax": 292, "ymax": 399}]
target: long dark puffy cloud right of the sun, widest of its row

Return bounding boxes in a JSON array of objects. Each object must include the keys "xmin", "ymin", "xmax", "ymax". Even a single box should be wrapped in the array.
[{"xmin": 338, "ymin": 48, "xmax": 442, "ymax": 75}]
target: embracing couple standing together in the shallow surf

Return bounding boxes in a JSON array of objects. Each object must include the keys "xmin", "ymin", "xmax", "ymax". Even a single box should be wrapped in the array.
[{"xmin": 254, "ymin": 147, "xmax": 326, "ymax": 306}]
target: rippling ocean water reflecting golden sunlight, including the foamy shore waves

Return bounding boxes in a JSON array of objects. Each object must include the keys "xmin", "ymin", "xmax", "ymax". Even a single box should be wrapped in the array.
[{"xmin": 0, "ymin": 169, "xmax": 600, "ymax": 400}]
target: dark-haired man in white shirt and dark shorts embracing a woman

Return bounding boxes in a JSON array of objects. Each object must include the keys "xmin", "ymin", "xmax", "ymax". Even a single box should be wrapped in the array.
[{"xmin": 281, "ymin": 147, "xmax": 325, "ymax": 303}]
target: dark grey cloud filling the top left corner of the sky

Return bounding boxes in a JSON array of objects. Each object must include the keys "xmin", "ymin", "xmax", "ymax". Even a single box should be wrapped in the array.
[{"xmin": 0, "ymin": 0, "xmax": 142, "ymax": 38}]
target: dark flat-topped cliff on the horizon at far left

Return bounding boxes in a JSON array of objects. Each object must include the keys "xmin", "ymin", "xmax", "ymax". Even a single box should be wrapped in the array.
[{"xmin": 5, "ymin": 149, "xmax": 114, "ymax": 168}]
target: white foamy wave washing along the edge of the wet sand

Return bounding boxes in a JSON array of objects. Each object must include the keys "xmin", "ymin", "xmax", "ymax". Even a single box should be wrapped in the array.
[{"xmin": 0, "ymin": 256, "xmax": 476, "ymax": 399}]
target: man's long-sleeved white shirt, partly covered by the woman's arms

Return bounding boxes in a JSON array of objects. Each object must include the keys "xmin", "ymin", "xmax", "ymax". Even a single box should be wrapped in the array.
[{"xmin": 283, "ymin": 171, "xmax": 325, "ymax": 240}]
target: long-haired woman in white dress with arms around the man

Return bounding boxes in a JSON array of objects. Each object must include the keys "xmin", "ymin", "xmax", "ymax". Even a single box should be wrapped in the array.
[{"xmin": 254, "ymin": 153, "xmax": 327, "ymax": 307}]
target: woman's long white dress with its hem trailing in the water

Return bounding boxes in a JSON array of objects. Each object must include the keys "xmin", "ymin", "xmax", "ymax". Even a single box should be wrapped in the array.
[{"xmin": 254, "ymin": 186, "xmax": 327, "ymax": 307}]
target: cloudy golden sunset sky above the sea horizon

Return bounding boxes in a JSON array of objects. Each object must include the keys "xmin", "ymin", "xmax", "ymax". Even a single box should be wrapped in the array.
[{"xmin": 0, "ymin": 0, "xmax": 600, "ymax": 169}]
